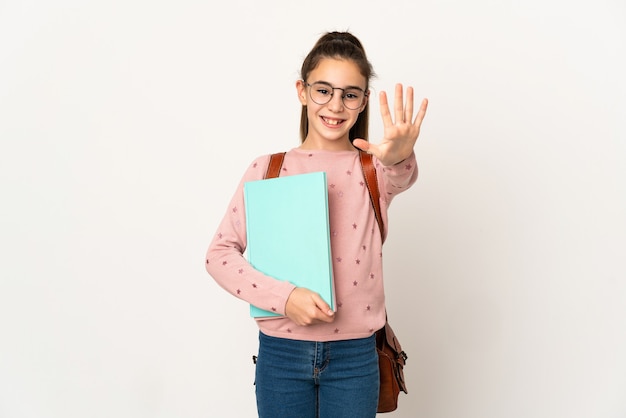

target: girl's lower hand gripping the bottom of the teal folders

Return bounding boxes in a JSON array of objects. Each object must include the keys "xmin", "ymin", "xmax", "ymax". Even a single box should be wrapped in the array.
[{"xmin": 285, "ymin": 287, "xmax": 335, "ymax": 326}]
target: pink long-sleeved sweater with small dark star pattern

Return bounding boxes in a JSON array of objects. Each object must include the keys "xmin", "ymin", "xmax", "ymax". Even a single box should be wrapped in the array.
[{"xmin": 206, "ymin": 148, "xmax": 417, "ymax": 341}]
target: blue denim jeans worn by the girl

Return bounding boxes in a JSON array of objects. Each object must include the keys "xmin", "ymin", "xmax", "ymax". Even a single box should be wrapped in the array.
[{"xmin": 255, "ymin": 332, "xmax": 380, "ymax": 418}]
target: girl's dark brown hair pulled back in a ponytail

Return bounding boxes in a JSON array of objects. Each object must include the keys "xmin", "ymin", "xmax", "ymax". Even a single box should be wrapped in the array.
[{"xmin": 300, "ymin": 32, "xmax": 375, "ymax": 142}]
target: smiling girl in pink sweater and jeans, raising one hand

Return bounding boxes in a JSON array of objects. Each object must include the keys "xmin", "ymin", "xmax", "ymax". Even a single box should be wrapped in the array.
[{"xmin": 206, "ymin": 32, "xmax": 428, "ymax": 418}]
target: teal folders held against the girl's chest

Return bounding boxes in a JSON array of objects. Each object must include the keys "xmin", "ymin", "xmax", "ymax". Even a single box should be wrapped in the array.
[{"xmin": 244, "ymin": 172, "xmax": 335, "ymax": 318}]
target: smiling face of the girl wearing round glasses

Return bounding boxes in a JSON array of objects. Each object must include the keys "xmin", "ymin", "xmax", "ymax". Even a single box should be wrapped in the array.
[{"xmin": 296, "ymin": 58, "xmax": 367, "ymax": 150}]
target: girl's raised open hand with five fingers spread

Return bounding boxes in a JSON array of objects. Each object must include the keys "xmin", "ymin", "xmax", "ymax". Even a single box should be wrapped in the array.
[{"xmin": 353, "ymin": 83, "xmax": 428, "ymax": 166}]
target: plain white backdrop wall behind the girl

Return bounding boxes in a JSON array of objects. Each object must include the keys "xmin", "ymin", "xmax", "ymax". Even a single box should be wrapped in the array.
[{"xmin": 0, "ymin": 0, "xmax": 626, "ymax": 418}]
